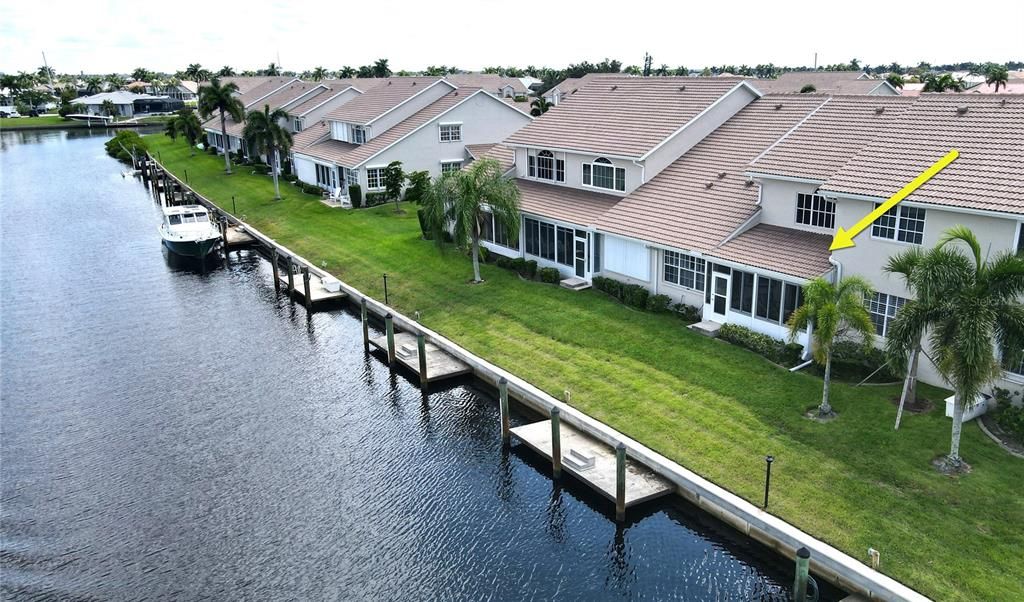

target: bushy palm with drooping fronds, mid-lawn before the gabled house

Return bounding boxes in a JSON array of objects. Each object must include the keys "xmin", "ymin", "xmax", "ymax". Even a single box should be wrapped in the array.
[{"xmin": 423, "ymin": 159, "xmax": 519, "ymax": 283}]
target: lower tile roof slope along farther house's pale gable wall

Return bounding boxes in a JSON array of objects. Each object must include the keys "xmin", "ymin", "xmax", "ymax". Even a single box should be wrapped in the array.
[{"xmin": 292, "ymin": 88, "xmax": 484, "ymax": 168}]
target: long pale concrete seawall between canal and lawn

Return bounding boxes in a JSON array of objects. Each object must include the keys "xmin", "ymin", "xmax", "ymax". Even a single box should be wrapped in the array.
[{"xmin": 155, "ymin": 156, "xmax": 929, "ymax": 601}]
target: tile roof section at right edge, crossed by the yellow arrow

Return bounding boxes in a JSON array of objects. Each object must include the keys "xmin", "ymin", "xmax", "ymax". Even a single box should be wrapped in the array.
[{"xmin": 821, "ymin": 94, "xmax": 1024, "ymax": 214}]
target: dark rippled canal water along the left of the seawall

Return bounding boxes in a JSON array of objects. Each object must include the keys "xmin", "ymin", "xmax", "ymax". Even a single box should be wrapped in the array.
[{"xmin": 0, "ymin": 131, "xmax": 836, "ymax": 600}]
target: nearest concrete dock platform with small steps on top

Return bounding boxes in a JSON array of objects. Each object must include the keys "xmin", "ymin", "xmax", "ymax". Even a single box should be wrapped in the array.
[{"xmin": 511, "ymin": 420, "xmax": 675, "ymax": 508}]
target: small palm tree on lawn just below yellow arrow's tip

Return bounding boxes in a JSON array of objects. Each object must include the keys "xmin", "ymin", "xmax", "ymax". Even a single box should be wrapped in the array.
[{"xmin": 788, "ymin": 276, "xmax": 874, "ymax": 418}]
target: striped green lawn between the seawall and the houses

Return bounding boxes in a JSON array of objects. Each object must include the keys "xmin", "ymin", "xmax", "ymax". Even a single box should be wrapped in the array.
[{"xmin": 146, "ymin": 135, "xmax": 1024, "ymax": 600}]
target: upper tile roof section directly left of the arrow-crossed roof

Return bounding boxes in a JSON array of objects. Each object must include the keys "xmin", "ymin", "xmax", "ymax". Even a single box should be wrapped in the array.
[{"xmin": 748, "ymin": 96, "xmax": 913, "ymax": 182}]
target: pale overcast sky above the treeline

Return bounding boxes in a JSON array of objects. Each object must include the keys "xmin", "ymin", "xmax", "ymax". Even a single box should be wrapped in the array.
[{"xmin": 0, "ymin": 0, "xmax": 1024, "ymax": 74}]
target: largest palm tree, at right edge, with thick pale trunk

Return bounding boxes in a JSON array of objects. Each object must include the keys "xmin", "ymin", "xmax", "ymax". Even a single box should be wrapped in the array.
[{"xmin": 888, "ymin": 226, "xmax": 1024, "ymax": 472}]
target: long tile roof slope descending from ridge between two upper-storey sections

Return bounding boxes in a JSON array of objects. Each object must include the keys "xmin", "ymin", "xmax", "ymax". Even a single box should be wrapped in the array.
[{"xmin": 597, "ymin": 95, "xmax": 824, "ymax": 251}]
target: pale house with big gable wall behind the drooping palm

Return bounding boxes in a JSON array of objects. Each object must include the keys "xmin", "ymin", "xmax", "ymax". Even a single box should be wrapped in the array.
[{"xmin": 292, "ymin": 77, "xmax": 532, "ymax": 195}]
